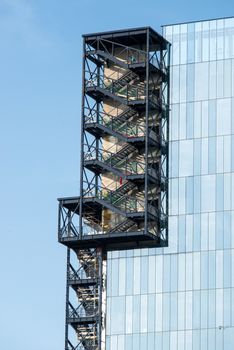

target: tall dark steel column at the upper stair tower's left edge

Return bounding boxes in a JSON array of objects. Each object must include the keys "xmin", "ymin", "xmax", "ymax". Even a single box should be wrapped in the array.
[{"xmin": 79, "ymin": 38, "xmax": 86, "ymax": 239}]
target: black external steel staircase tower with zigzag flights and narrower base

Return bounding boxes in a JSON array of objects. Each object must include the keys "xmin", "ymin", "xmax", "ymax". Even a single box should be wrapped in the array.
[{"xmin": 58, "ymin": 27, "xmax": 170, "ymax": 350}]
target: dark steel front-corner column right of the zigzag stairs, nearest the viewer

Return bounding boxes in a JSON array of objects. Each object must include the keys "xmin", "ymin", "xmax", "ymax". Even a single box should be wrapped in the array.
[{"xmin": 144, "ymin": 28, "xmax": 150, "ymax": 233}]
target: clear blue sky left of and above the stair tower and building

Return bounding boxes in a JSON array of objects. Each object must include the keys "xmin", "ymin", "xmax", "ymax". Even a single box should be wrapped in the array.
[{"xmin": 0, "ymin": 0, "xmax": 234, "ymax": 350}]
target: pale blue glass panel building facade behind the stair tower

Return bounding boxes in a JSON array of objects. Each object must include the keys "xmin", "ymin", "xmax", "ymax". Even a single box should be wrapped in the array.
[{"xmin": 106, "ymin": 18, "xmax": 234, "ymax": 350}]
